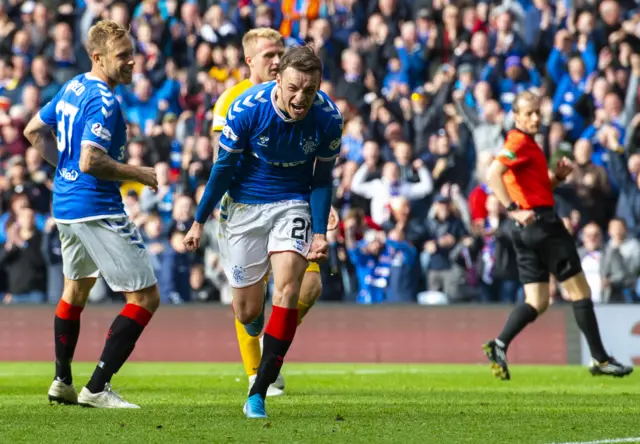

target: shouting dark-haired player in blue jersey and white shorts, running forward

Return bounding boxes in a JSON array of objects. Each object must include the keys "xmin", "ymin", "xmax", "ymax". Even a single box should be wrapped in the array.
[{"xmin": 185, "ymin": 46, "xmax": 342, "ymax": 418}]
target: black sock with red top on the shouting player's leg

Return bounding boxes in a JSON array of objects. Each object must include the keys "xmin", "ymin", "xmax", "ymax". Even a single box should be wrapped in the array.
[{"xmin": 249, "ymin": 306, "xmax": 298, "ymax": 399}]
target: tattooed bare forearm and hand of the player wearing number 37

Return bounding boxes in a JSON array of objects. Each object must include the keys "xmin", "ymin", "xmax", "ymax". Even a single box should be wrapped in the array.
[{"xmin": 80, "ymin": 144, "xmax": 158, "ymax": 189}]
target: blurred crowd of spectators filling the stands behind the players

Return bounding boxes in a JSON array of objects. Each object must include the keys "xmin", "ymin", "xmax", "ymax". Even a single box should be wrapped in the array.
[{"xmin": 0, "ymin": 0, "xmax": 640, "ymax": 304}]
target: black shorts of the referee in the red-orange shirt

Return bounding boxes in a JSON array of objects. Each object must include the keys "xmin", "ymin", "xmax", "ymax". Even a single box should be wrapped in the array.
[{"xmin": 512, "ymin": 207, "xmax": 582, "ymax": 285}]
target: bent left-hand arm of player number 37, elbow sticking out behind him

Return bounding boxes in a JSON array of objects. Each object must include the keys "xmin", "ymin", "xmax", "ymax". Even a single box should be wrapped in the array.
[{"xmin": 24, "ymin": 90, "xmax": 62, "ymax": 167}]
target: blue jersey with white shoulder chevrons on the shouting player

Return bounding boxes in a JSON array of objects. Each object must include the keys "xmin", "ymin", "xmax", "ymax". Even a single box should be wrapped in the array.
[{"xmin": 219, "ymin": 81, "xmax": 342, "ymax": 204}]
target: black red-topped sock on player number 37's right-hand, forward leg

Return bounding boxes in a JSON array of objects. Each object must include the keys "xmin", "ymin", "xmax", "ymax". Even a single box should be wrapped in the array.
[{"xmin": 87, "ymin": 304, "xmax": 153, "ymax": 393}]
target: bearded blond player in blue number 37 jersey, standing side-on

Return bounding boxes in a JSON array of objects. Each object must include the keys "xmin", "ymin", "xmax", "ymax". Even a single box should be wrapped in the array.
[{"xmin": 24, "ymin": 20, "xmax": 160, "ymax": 408}]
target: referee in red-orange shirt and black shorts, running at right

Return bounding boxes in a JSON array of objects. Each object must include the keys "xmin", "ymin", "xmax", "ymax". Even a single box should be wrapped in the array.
[{"xmin": 483, "ymin": 91, "xmax": 633, "ymax": 380}]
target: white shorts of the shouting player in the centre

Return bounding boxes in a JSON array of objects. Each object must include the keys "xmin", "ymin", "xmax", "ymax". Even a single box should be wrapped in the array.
[{"xmin": 218, "ymin": 196, "xmax": 311, "ymax": 288}]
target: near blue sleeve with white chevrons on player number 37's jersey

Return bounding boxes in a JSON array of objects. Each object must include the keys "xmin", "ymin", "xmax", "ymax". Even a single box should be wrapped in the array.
[{"xmin": 81, "ymin": 91, "xmax": 120, "ymax": 152}]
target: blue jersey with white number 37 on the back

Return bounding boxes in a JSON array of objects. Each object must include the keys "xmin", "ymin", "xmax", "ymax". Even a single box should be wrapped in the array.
[{"xmin": 40, "ymin": 74, "xmax": 127, "ymax": 222}]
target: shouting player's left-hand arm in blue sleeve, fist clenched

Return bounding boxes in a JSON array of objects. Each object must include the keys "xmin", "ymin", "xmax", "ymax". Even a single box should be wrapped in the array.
[{"xmin": 184, "ymin": 103, "xmax": 250, "ymax": 251}]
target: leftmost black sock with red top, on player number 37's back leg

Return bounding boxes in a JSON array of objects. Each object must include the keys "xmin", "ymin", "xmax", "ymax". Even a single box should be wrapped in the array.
[{"xmin": 53, "ymin": 299, "xmax": 84, "ymax": 384}]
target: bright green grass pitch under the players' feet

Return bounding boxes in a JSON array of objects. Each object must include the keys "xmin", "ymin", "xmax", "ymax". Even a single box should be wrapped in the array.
[{"xmin": 0, "ymin": 363, "xmax": 640, "ymax": 444}]
